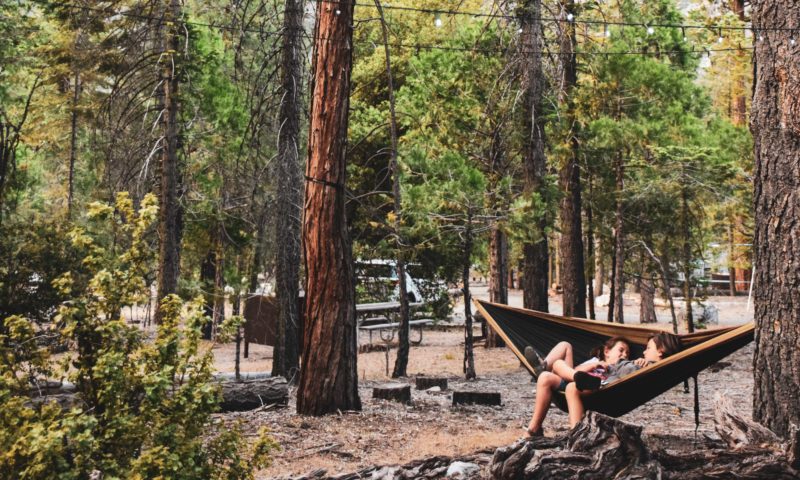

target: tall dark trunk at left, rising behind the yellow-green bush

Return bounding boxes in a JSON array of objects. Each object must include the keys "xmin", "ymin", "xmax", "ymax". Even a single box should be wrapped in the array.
[{"xmin": 155, "ymin": 0, "xmax": 181, "ymax": 323}]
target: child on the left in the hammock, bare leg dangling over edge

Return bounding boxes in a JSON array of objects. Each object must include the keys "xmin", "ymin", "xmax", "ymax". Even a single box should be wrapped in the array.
[{"xmin": 525, "ymin": 337, "xmax": 630, "ymax": 437}]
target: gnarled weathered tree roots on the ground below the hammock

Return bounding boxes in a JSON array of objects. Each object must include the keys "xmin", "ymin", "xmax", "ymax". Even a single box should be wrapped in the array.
[{"xmin": 278, "ymin": 399, "xmax": 800, "ymax": 480}]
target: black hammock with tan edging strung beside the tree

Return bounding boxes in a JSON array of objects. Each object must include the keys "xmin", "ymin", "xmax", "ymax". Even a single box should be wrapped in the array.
[{"xmin": 474, "ymin": 300, "xmax": 754, "ymax": 417}]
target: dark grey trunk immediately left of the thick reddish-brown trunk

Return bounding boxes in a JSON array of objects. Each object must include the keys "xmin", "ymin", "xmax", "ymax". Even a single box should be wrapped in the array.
[{"xmin": 272, "ymin": 0, "xmax": 305, "ymax": 380}]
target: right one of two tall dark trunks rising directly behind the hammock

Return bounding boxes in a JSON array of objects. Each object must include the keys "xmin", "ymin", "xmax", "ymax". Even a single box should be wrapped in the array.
[{"xmin": 558, "ymin": 0, "xmax": 586, "ymax": 317}]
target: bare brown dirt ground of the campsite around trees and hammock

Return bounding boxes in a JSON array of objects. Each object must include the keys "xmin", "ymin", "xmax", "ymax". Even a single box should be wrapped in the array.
[{"xmin": 209, "ymin": 290, "xmax": 753, "ymax": 479}]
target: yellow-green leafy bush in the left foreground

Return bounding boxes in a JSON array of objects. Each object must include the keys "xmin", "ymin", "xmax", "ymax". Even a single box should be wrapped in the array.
[{"xmin": 0, "ymin": 194, "xmax": 275, "ymax": 479}]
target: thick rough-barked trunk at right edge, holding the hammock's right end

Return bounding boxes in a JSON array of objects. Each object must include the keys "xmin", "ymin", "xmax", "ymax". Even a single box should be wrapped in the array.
[{"xmin": 750, "ymin": 0, "xmax": 800, "ymax": 438}]
